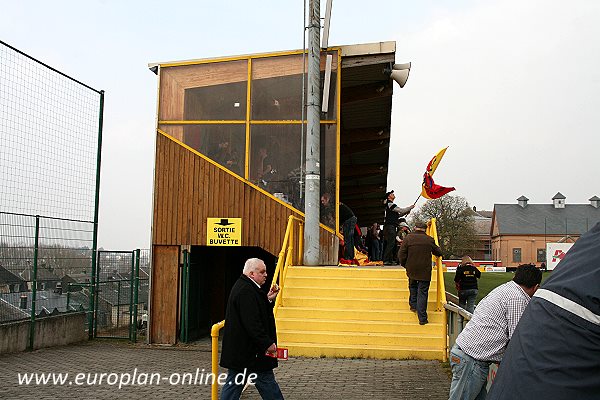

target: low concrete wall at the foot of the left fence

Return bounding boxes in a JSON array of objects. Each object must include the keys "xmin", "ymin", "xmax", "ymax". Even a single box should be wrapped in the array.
[{"xmin": 0, "ymin": 312, "xmax": 88, "ymax": 354}]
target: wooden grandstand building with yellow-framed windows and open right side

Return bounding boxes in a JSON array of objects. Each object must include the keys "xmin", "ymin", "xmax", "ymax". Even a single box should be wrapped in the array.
[{"xmin": 149, "ymin": 42, "xmax": 395, "ymax": 344}]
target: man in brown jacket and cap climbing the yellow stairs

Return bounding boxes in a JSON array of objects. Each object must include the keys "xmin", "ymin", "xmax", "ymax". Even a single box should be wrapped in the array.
[{"xmin": 399, "ymin": 222, "xmax": 442, "ymax": 325}]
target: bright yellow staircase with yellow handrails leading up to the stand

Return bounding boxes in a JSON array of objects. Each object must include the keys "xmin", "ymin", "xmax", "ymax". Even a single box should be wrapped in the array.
[{"xmin": 273, "ymin": 218, "xmax": 447, "ymax": 360}]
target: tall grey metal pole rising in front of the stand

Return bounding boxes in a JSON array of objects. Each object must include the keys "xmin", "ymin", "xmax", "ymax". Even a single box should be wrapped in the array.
[{"xmin": 304, "ymin": 0, "xmax": 321, "ymax": 265}]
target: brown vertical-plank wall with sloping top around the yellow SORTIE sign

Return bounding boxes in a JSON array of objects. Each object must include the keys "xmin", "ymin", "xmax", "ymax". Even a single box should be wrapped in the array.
[{"xmin": 152, "ymin": 134, "xmax": 337, "ymax": 265}]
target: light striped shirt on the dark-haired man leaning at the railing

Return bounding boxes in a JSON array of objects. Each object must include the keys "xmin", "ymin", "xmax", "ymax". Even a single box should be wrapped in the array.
[{"xmin": 456, "ymin": 281, "xmax": 530, "ymax": 362}]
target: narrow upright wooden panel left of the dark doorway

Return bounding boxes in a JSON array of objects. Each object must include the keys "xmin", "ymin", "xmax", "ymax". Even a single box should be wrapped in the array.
[{"xmin": 150, "ymin": 246, "xmax": 179, "ymax": 344}]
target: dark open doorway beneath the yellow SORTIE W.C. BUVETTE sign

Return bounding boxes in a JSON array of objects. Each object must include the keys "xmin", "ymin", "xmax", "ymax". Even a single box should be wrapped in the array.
[{"xmin": 187, "ymin": 246, "xmax": 277, "ymax": 341}]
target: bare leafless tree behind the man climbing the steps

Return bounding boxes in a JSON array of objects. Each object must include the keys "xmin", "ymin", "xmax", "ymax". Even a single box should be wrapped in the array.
[{"xmin": 411, "ymin": 195, "xmax": 477, "ymax": 259}]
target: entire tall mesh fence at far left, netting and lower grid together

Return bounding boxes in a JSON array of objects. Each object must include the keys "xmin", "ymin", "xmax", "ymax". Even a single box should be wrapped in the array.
[{"xmin": 0, "ymin": 41, "xmax": 104, "ymax": 348}]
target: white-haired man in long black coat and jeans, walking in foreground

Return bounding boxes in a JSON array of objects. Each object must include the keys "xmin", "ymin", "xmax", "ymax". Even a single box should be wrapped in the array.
[{"xmin": 221, "ymin": 258, "xmax": 283, "ymax": 400}]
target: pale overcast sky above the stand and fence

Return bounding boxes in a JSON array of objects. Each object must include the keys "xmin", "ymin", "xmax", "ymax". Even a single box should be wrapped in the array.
[{"xmin": 0, "ymin": 0, "xmax": 600, "ymax": 250}]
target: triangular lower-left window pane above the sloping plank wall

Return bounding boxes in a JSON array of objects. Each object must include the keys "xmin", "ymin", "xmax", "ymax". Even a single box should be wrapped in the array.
[{"xmin": 160, "ymin": 124, "xmax": 246, "ymax": 177}]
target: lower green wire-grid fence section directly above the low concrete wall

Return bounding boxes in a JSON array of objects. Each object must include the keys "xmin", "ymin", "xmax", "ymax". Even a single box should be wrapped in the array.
[{"xmin": 0, "ymin": 212, "xmax": 94, "ymax": 329}]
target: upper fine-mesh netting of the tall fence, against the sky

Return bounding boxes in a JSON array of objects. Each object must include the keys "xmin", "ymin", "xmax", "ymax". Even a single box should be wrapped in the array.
[{"xmin": 0, "ymin": 41, "xmax": 102, "ymax": 221}]
